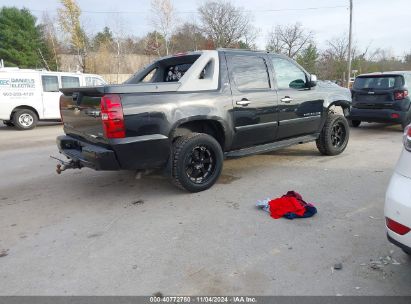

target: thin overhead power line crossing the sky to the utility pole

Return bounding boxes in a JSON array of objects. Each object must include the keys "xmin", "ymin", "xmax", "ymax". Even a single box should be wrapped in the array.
[{"xmin": 31, "ymin": 5, "xmax": 348, "ymax": 14}]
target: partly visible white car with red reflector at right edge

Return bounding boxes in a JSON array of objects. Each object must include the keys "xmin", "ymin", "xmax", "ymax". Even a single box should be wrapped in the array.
[{"xmin": 384, "ymin": 125, "xmax": 411, "ymax": 255}]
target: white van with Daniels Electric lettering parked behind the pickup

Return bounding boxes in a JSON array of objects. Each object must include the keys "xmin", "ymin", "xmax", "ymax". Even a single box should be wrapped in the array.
[{"xmin": 0, "ymin": 67, "xmax": 106, "ymax": 130}]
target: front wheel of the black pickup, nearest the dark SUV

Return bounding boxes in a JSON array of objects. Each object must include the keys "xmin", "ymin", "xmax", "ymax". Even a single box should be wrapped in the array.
[{"xmin": 316, "ymin": 113, "xmax": 350, "ymax": 155}]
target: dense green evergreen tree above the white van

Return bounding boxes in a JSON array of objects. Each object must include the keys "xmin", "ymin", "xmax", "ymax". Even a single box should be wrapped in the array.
[{"xmin": 0, "ymin": 7, "xmax": 51, "ymax": 68}]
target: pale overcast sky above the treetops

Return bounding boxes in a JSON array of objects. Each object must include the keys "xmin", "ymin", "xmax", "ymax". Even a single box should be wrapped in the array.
[{"xmin": 0, "ymin": 0, "xmax": 411, "ymax": 56}]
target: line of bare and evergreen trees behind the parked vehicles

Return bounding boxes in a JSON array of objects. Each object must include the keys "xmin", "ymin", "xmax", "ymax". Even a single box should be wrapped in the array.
[{"xmin": 0, "ymin": 0, "xmax": 411, "ymax": 81}]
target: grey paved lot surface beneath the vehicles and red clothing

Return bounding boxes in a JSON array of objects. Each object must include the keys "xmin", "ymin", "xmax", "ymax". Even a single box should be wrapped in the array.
[{"xmin": 0, "ymin": 120, "xmax": 411, "ymax": 295}]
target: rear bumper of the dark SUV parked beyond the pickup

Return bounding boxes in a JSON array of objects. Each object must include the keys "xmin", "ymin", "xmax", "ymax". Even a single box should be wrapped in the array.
[{"xmin": 348, "ymin": 108, "xmax": 409, "ymax": 123}]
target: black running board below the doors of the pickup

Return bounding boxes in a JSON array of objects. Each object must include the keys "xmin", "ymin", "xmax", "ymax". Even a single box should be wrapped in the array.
[{"xmin": 224, "ymin": 134, "xmax": 320, "ymax": 158}]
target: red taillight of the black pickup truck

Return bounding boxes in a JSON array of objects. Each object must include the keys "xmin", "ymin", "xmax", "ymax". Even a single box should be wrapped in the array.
[{"xmin": 100, "ymin": 94, "xmax": 126, "ymax": 138}]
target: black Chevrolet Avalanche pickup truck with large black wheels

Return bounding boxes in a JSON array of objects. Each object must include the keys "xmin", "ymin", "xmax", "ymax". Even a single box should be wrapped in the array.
[{"xmin": 57, "ymin": 49, "xmax": 351, "ymax": 192}]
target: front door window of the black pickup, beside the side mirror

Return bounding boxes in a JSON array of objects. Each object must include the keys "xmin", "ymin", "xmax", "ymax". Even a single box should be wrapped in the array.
[{"xmin": 272, "ymin": 57, "xmax": 307, "ymax": 90}]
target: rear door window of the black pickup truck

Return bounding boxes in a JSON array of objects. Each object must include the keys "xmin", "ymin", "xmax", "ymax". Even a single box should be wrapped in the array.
[{"xmin": 228, "ymin": 55, "xmax": 270, "ymax": 91}]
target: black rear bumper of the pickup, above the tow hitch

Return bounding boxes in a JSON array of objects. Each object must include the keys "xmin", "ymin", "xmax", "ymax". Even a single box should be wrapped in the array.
[{"xmin": 57, "ymin": 134, "xmax": 170, "ymax": 171}]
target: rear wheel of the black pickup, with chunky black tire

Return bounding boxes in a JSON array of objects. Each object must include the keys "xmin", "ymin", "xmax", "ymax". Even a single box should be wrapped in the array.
[{"xmin": 172, "ymin": 133, "xmax": 224, "ymax": 192}]
